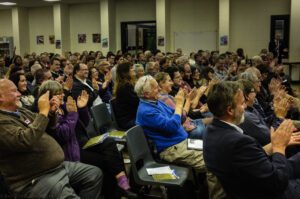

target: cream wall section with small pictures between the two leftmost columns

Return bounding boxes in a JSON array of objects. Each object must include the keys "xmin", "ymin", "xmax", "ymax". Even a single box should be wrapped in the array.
[{"xmin": 28, "ymin": 6, "xmax": 55, "ymax": 53}]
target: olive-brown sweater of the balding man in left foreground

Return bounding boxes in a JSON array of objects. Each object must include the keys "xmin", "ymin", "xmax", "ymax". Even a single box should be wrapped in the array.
[{"xmin": 0, "ymin": 108, "xmax": 64, "ymax": 191}]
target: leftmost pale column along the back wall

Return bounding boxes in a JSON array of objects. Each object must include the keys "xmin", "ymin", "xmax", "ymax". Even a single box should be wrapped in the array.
[{"xmin": 12, "ymin": 7, "xmax": 30, "ymax": 56}]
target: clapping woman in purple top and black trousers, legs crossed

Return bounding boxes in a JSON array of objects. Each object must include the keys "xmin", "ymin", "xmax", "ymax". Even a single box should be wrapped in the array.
[{"xmin": 39, "ymin": 80, "xmax": 134, "ymax": 198}]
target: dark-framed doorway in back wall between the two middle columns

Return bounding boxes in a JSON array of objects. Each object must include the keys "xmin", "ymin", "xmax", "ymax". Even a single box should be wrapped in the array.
[{"xmin": 121, "ymin": 21, "xmax": 156, "ymax": 54}]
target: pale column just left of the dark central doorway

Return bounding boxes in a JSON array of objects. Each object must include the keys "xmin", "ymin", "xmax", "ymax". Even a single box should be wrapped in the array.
[{"xmin": 100, "ymin": 0, "xmax": 116, "ymax": 56}]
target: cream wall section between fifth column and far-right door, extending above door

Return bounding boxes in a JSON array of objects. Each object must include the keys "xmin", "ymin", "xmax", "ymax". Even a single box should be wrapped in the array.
[{"xmin": 229, "ymin": 0, "xmax": 291, "ymax": 57}]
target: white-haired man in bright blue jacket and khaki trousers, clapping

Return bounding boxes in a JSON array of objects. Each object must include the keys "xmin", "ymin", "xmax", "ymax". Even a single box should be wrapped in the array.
[{"xmin": 135, "ymin": 75, "xmax": 222, "ymax": 198}]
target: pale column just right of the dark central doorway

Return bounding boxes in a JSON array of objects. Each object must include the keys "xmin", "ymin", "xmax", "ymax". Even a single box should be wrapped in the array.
[{"xmin": 156, "ymin": 0, "xmax": 170, "ymax": 52}]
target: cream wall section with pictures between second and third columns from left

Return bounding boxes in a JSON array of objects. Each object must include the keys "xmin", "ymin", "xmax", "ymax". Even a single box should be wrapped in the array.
[{"xmin": 70, "ymin": 3, "xmax": 101, "ymax": 52}]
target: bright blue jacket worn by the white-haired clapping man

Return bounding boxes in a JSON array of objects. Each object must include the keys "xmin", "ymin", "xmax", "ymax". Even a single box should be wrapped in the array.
[{"xmin": 136, "ymin": 100, "xmax": 188, "ymax": 153}]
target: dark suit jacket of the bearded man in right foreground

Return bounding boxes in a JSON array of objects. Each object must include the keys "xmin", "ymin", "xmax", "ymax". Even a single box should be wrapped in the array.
[{"xmin": 203, "ymin": 119, "xmax": 300, "ymax": 199}]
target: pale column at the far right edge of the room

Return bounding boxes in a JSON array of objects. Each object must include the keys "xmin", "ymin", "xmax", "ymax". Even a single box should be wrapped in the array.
[{"xmin": 289, "ymin": 0, "xmax": 300, "ymax": 62}]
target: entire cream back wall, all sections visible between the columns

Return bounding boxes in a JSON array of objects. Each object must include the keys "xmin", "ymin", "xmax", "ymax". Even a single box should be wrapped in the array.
[{"xmin": 0, "ymin": 0, "xmax": 291, "ymax": 57}]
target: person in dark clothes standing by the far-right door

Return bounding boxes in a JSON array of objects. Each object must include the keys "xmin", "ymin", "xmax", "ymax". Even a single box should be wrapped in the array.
[{"xmin": 269, "ymin": 33, "xmax": 288, "ymax": 64}]
